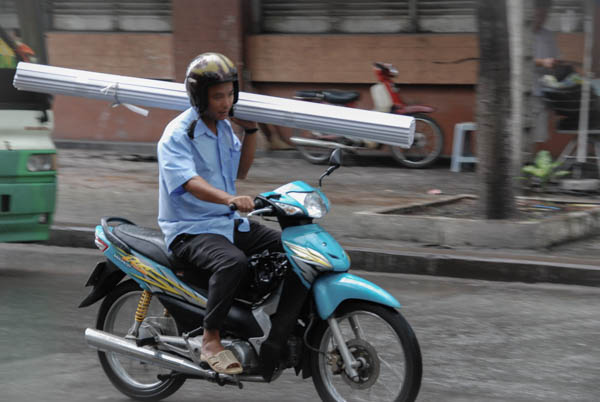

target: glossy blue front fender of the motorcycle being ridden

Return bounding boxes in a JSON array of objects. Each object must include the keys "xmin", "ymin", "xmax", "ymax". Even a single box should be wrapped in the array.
[{"xmin": 313, "ymin": 273, "xmax": 400, "ymax": 320}]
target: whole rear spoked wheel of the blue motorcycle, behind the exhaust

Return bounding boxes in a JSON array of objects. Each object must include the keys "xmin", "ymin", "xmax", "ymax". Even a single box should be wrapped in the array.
[{"xmin": 96, "ymin": 281, "xmax": 185, "ymax": 401}]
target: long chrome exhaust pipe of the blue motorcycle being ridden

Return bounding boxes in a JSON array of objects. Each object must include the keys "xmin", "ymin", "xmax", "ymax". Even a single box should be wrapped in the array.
[{"xmin": 85, "ymin": 328, "xmax": 230, "ymax": 384}]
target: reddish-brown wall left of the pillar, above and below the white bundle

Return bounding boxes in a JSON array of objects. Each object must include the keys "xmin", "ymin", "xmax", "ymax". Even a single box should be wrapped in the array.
[{"xmin": 47, "ymin": 32, "xmax": 177, "ymax": 142}]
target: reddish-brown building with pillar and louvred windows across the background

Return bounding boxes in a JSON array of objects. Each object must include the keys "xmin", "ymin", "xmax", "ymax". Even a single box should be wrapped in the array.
[{"xmin": 0, "ymin": 0, "xmax": 600, "ymax": 155}]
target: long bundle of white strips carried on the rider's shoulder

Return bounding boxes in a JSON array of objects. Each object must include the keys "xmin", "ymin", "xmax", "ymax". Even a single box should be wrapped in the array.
[{"xmin": 13, "ymin": 62, "xmax": 415, "ymax": 148}]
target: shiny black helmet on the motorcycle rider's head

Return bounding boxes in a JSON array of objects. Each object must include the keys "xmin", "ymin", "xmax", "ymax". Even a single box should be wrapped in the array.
[{"xmin": 185, "ymin": 53, "xmax": 239, "ymax": 114}]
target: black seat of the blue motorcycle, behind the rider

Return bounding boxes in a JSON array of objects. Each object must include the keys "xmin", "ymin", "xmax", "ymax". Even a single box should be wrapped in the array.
[{"xmin": 113, "ymin": 224, "xmax": 187, "ymax": 270}]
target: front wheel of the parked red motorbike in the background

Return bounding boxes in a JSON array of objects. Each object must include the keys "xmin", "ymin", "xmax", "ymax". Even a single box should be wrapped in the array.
[{"xmin": 391, "ymin": 114, "xmax": 444, "ymax": 168}]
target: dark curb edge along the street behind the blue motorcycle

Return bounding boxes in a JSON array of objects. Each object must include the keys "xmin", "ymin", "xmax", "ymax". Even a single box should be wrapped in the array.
[{"xmin": 44, "ymin": 225, "xmax": 600, "ymax": 287}]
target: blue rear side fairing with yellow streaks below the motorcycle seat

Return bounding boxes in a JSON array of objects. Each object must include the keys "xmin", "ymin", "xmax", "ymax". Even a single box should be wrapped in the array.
[{"xmin": 96, "ymin": 226, "xmax": 206, "ymax": 308}]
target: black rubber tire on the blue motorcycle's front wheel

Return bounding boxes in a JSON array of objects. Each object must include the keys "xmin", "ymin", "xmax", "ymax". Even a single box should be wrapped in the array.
[{"xmin": 311, "ymin": 301, "xmax": 423, "ymax": 402}]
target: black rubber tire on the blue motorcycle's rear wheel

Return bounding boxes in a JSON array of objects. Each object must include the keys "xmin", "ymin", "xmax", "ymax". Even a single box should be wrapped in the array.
[{"xmin": 96, "ymin": 280, "xmax": 185, "ymax": 401}]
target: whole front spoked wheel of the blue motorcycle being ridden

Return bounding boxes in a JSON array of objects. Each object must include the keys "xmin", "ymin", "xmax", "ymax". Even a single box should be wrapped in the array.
[{"xmin": 311, "ymin": 302, "xmax": 422, "ymax": 402}]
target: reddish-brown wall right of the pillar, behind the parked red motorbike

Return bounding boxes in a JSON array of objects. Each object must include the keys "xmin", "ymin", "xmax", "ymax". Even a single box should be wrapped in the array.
[{"xmin": 247, "ymin": 34, "xmax": 583, "ymax": 155}]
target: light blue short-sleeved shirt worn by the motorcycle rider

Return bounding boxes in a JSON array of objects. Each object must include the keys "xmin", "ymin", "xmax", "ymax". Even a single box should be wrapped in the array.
[{"xmin": 157, "ymin": 108, "xmax": 250, "ymax": 250}]
